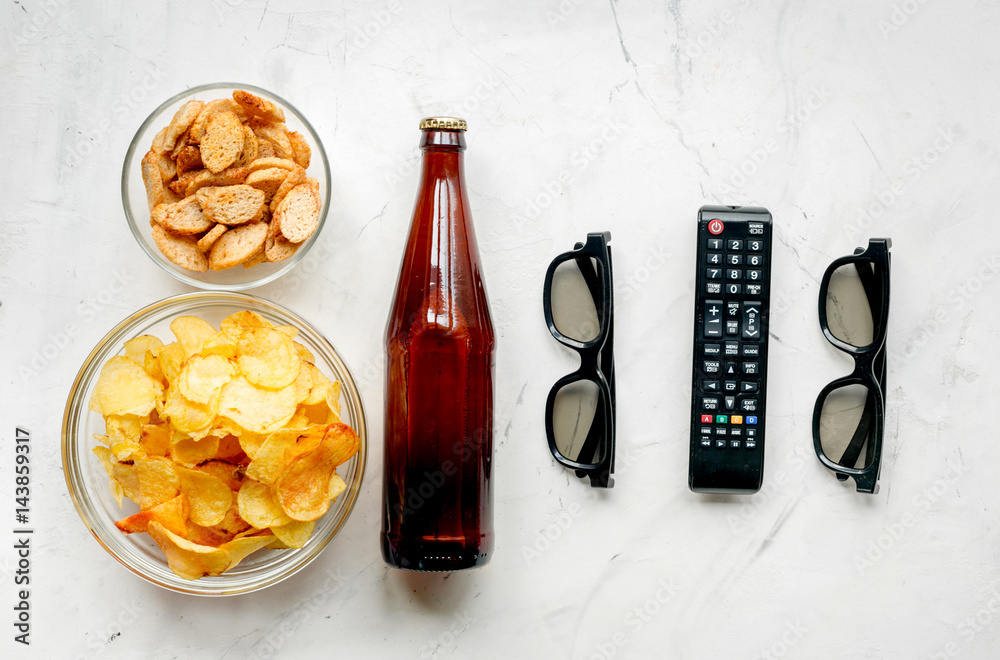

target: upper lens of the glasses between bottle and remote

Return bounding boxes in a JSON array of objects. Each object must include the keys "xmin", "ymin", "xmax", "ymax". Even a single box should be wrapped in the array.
[{"xmin": 551, "ymin": 257, "xmax": 603, "ymax": 342}]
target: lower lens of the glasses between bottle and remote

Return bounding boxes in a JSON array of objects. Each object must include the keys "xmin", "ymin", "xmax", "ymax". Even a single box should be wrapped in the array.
[{"xmin": 552, "ymin": 380, "xmax": 606, "ymax": 465}]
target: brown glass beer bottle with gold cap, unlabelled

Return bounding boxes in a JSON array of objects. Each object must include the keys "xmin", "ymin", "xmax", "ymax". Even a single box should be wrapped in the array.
[{"xmin": 382, "ymin": 117, "xmax": 495, "ymax": 571}]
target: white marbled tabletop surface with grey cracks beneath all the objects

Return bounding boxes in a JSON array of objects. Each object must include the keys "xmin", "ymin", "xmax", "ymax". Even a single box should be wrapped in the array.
[{"xmin": 0, "ymin": 0, "xmax": 1000, "ymax": 659}]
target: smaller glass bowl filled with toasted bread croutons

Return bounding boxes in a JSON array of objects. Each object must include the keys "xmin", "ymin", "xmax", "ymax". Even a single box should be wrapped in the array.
[{"xmin": 122, "ymin": 83, "xmax": 330, "ymax": 291}]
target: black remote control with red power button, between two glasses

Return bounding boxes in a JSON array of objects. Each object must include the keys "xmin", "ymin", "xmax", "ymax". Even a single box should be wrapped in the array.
[{"xmin": 688, "ymin": 206, "xmax": 771, "ymax": 493}]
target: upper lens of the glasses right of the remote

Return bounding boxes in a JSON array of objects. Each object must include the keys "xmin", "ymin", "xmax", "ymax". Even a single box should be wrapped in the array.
[{"xmin": 826, "ymin": 262, "xmax": 875, "ymax": 348}]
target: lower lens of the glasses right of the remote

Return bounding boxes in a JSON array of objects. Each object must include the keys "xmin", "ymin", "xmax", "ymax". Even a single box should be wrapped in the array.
[{"xmin": 819, "ymin": 384, "xmax": 875, "ymax": 468}]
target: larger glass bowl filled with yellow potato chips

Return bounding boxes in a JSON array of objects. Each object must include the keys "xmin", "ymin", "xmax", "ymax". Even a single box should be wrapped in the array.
[{"xmin": 62, "ymin": 292, "xmax": 367, "ymax": 596}]
